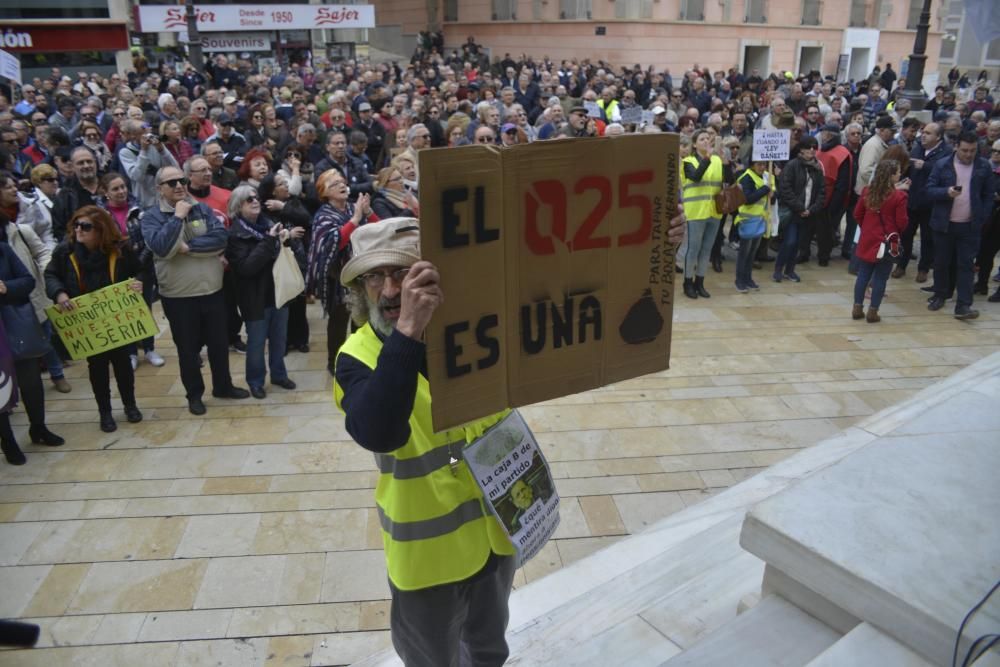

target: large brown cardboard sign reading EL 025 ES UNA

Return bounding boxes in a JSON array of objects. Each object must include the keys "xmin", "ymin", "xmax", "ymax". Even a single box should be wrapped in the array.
[{"xmin": 419, "ymin": 134, "xmax": 678, "ymax": 430}]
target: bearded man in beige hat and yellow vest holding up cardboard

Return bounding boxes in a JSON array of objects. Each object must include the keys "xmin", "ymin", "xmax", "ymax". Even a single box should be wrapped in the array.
[{"xmin": 334, "ymin": 210, "xmax": 684, "ymax": 667}]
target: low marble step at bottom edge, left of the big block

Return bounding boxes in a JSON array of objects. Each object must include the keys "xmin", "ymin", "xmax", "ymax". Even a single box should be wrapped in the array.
[{"xmin": 663, "ymin": 595, "xmax": 846, "ymax": 667}]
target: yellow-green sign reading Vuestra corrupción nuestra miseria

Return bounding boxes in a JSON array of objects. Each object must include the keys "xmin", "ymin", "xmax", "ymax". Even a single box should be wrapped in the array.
[{"xmin": 45, "ymin": 279, "xmax": 160, "ymax": 359}]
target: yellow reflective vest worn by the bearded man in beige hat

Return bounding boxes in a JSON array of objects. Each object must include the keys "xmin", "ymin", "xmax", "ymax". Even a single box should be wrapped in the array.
[{"xmin": 333, "ymin": 324, "xmax": 514, "ymax": 591}]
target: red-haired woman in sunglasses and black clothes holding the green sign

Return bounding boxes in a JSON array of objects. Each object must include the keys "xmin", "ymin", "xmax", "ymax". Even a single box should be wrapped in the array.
[{"xmin": 45, "ymin": 206, "xmax": 146, "ymax": 433}]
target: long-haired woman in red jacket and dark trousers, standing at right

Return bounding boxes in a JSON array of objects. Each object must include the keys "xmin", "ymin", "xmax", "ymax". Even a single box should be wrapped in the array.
[{"xmin": 851, "ymin": 160, "xmax": 910, "ymax": 322}]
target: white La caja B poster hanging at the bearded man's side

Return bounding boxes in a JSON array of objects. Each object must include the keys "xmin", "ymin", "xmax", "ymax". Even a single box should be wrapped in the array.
[{"xmin": 463, "ymin": 410, "xmax": 559, "ymax": 567}]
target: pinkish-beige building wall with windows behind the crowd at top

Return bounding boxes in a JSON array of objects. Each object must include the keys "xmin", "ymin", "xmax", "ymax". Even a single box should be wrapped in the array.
[{"xmin": 374, "ymin": 0, "xmax": 940, "ymax": 82}]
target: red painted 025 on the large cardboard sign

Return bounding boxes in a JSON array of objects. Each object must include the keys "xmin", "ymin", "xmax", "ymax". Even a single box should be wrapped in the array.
[{"xmin": 524, "ymin": 169, "xmax": 653, "ymax": 255}]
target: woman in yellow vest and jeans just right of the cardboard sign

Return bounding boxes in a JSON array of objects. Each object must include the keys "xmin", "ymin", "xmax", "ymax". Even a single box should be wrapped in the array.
[{"xmin": 681, "ymin": 130, "xmax": 723, "ymax": 299}]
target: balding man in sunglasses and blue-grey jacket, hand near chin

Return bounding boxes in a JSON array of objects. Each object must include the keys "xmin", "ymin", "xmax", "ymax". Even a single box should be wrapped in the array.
[{"xmin": 141, "ymin": 167, "xmax": 250, "ymax": 415}]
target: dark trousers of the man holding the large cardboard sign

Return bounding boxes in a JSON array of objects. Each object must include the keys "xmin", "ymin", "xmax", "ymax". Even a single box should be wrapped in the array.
[{"xmin": 389, "ymin": 556, "xmax": 514, "ymax": 667}]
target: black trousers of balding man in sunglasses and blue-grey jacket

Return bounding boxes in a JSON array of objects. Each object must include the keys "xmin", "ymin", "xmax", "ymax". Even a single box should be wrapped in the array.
[{"xmin": 160, "ymin": 290, "xmax": 233, "ymax": 399}]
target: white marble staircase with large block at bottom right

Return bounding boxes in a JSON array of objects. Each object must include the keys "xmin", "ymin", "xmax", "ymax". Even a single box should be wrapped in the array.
[{"xmin": 359, "ymin": 353, "xmax": 1000, "ymax": 667}]
